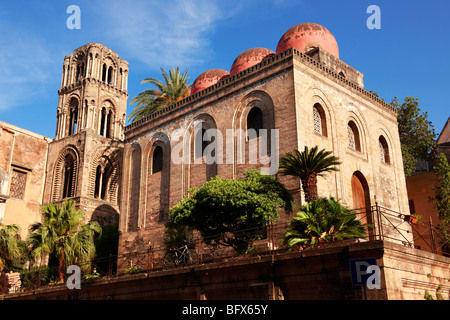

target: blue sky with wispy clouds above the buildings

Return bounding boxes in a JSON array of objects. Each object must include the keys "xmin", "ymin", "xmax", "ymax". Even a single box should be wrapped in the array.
[{"xmin": 0, "ymin": 0, "xmax": 450, "ymax": 138}]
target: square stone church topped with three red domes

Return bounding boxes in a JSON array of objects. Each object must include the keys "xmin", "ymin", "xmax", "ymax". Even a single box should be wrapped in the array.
[{"xmin": 119, "ymin": 23, "xmax": 409, "ymax": 253}]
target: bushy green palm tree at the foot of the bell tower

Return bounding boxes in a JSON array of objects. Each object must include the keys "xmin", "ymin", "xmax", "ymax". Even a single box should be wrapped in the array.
[{"xmin": 28, "ymin": 200, "xmax": 102, "ymax": 282}]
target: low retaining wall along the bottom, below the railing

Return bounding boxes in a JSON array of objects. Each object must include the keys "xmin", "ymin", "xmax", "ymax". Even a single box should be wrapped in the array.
[{"xmin": 0, "ymin": 241, "xmax": 450, "ymax": 300}]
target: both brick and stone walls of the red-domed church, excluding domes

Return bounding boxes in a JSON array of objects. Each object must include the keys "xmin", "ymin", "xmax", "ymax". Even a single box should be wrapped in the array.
[{"xmin": 119, "ymin": 50, "xmax": 408, "ymax": 253}]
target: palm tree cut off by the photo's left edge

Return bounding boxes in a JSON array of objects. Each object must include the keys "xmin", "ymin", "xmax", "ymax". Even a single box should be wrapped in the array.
[{"xmin": 0, "ymin": 223, "xmax": 21, "ymax": 272}]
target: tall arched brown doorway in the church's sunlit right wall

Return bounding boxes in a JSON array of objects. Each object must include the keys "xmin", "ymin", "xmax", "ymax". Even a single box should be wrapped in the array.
[{"xmin": 352, "ymin": 171, "xmax": 372, "ymax": 228}]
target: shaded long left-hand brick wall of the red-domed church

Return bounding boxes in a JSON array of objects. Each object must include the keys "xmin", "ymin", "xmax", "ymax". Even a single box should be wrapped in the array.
[{"xmin": 119, "ymin": 53, "xmax": 299, "ymax": 253}]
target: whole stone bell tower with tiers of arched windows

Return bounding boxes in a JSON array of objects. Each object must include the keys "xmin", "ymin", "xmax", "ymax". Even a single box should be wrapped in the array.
[{"xmin": 44, "ymin": 43, "xmax": 128, "ymax": 224}]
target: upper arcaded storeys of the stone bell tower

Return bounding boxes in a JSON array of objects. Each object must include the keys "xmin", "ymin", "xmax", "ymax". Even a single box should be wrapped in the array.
[{"xmin": 55, "ymin": 43, "xmax": 128, "ymax": 140}]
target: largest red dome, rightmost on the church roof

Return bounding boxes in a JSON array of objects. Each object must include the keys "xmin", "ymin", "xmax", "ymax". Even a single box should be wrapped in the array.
[{"xmin": 277, "ymin": 23, "xmax": 339, "ymax": 58}]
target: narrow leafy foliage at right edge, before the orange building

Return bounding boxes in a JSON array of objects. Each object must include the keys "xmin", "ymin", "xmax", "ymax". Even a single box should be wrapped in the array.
[{"xmin": 431, "ymin": 153, "xmax": 450, "ymax": 250}]
